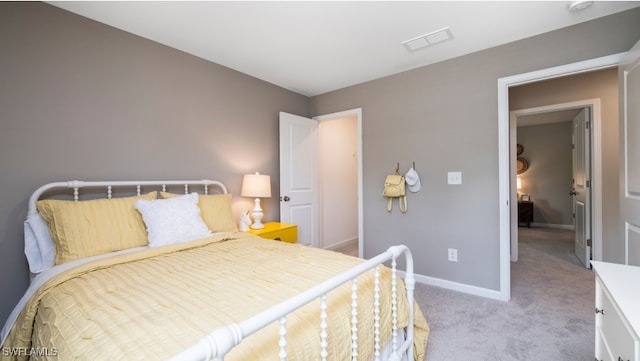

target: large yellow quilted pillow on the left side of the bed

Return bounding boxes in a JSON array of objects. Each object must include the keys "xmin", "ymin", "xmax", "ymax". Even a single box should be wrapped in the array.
[{"xmin": 37, "ymin": 192, "xmax": 157, "ymax": 264}]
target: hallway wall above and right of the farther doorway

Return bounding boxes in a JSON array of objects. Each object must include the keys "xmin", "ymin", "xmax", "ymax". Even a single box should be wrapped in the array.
[{"xmin": 509, "ymin": 66, "xmax": 624, "ymax": 263}]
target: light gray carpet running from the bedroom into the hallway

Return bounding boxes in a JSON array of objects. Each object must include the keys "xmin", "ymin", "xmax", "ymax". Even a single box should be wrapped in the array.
[{"xmin": 416, "ymin": 228, "xmax": 595, "ymax": 361}]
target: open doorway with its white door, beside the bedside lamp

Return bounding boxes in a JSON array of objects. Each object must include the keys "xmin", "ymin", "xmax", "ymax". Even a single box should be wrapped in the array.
[{"xmin": 279, "ymin": 109, "xmax": 363, "ymax": 256}]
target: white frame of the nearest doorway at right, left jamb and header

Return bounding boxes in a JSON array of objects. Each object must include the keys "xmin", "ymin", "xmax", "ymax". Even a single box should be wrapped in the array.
[{"xmin": 498, "ymin": 53, "xmax": 625, "ymax": 301}]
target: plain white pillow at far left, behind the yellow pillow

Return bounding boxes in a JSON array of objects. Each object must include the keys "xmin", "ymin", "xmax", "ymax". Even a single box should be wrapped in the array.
[{"xmin": 24, "ymin": 213, "xmax": 56, "ymax": 273}]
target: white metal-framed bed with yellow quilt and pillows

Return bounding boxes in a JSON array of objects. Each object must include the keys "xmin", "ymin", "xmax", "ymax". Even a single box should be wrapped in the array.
[{"xmin": 0, "ymin": 180, "xmax": 429, "ymax": 360}]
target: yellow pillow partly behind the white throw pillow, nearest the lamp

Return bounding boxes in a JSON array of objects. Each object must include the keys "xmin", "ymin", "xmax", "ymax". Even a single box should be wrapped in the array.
[{"xmin": 160, "ymin": 192, "xmax": 238, "ymax": 232}]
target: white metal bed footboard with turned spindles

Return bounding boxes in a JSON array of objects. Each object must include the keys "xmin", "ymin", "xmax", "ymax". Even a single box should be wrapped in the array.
[{"xmin": 172, "ymin": 245, "xmax": 415, "ymax": 361}]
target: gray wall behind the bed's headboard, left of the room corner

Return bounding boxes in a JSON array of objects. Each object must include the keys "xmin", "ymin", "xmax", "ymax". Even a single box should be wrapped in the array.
[{"xmin": 0, "ymin": 2, "xmax": 309, "ymax": 322}]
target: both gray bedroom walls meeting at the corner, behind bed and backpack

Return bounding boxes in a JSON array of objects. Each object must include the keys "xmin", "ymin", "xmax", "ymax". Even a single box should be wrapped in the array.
[{"xmin": 0, "ymin": 2, "xmax": 640, "ymax": 320}]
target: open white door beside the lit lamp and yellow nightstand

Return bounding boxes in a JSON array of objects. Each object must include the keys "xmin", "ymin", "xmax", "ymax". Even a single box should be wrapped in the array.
[{"xmin": 280, "ymin": 112, "xmax": 319, "ymax": 247}]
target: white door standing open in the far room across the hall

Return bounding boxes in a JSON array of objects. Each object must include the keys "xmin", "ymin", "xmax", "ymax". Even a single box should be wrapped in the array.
[{"xmin": 571, "ymin": 108, "xmax": 591, "ymax": 268}]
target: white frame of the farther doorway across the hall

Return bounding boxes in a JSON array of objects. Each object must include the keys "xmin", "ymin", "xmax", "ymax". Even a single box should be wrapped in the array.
[{"xmin": 509, "ymin": 98, "xmax": 602, "ymax": 262}]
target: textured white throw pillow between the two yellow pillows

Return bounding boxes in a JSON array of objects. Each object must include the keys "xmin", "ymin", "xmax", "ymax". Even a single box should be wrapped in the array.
[{"xmin": 135, "ymin": 193, "xmax": 211, "ymax": 247}]
